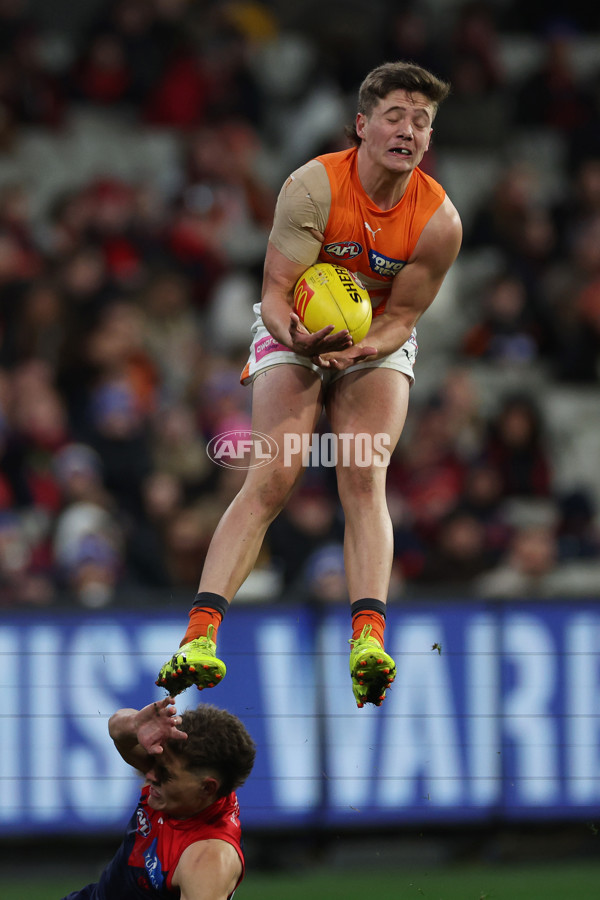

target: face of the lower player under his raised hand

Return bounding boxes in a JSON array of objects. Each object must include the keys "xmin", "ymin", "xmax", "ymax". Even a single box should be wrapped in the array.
[{"xmin": 146, "ymin": 750, "xmax": 215, "ymax": 819}]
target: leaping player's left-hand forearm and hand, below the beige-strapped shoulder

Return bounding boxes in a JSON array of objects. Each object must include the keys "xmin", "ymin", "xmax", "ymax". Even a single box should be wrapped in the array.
[{"xmin": 261, "ymin": 243, "xmax": 352, "ymax": 357}]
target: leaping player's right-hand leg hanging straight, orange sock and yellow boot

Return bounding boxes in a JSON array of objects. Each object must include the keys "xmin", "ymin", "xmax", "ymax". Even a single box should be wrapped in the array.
[{"xmin": 327, "ymin": 368, "xmax": 410, "ymax": 706}]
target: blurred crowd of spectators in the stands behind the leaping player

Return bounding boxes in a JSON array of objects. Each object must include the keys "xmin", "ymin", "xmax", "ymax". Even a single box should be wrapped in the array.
[{"xmin": 0, "ymin": 0, "xmax": 600, "ymax": 608}]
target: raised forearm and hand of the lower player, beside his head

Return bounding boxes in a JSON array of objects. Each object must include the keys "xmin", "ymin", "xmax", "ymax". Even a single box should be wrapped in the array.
[{"xmin": 108, "ymin": 697, "xmax": 187, "ymax": 772}]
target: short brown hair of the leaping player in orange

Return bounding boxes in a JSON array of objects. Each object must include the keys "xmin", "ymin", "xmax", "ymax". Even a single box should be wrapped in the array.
[{"xmin": 346, "ymin": 62, "xmax": 450, "ymax": 147}]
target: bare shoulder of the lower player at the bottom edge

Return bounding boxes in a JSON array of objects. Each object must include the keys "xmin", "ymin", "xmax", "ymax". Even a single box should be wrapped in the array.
[{"xmin": 172, "ymin": 840, "xmax": 242, "ymax": 900}]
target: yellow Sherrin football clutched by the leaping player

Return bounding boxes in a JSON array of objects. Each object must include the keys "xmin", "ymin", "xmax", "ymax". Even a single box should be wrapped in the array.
[{"xmin": 294, "ymin": 262, "xmax": 373, "ymax": 344}]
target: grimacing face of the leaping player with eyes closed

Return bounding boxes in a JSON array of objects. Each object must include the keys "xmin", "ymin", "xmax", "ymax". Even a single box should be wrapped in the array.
[{"xmin": 356, "ymin": 90, "xmax": 434, "ymax": 174}]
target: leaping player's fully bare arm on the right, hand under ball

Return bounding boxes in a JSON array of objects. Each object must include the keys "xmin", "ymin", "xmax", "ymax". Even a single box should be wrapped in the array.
[{"xmin": 326, "ymin": 197, "xmax": 462, "ymax": 369}]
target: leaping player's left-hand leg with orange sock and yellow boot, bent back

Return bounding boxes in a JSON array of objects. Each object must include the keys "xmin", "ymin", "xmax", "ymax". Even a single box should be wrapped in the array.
[{"xmin": 157, "ymin": 364, "xmax": 322, "ymax": 695}]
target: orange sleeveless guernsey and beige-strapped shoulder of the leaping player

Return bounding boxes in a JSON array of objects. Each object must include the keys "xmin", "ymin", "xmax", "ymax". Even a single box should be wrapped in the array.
[{"xmin": 269, "ymin": 147, "xmax": 446, "ymax": 315}]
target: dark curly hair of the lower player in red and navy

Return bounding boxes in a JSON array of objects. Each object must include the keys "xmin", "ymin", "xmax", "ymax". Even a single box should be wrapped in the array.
[{"xmin": 169, "ymin": 704, "xmax": 256, "ymax": 797}]
